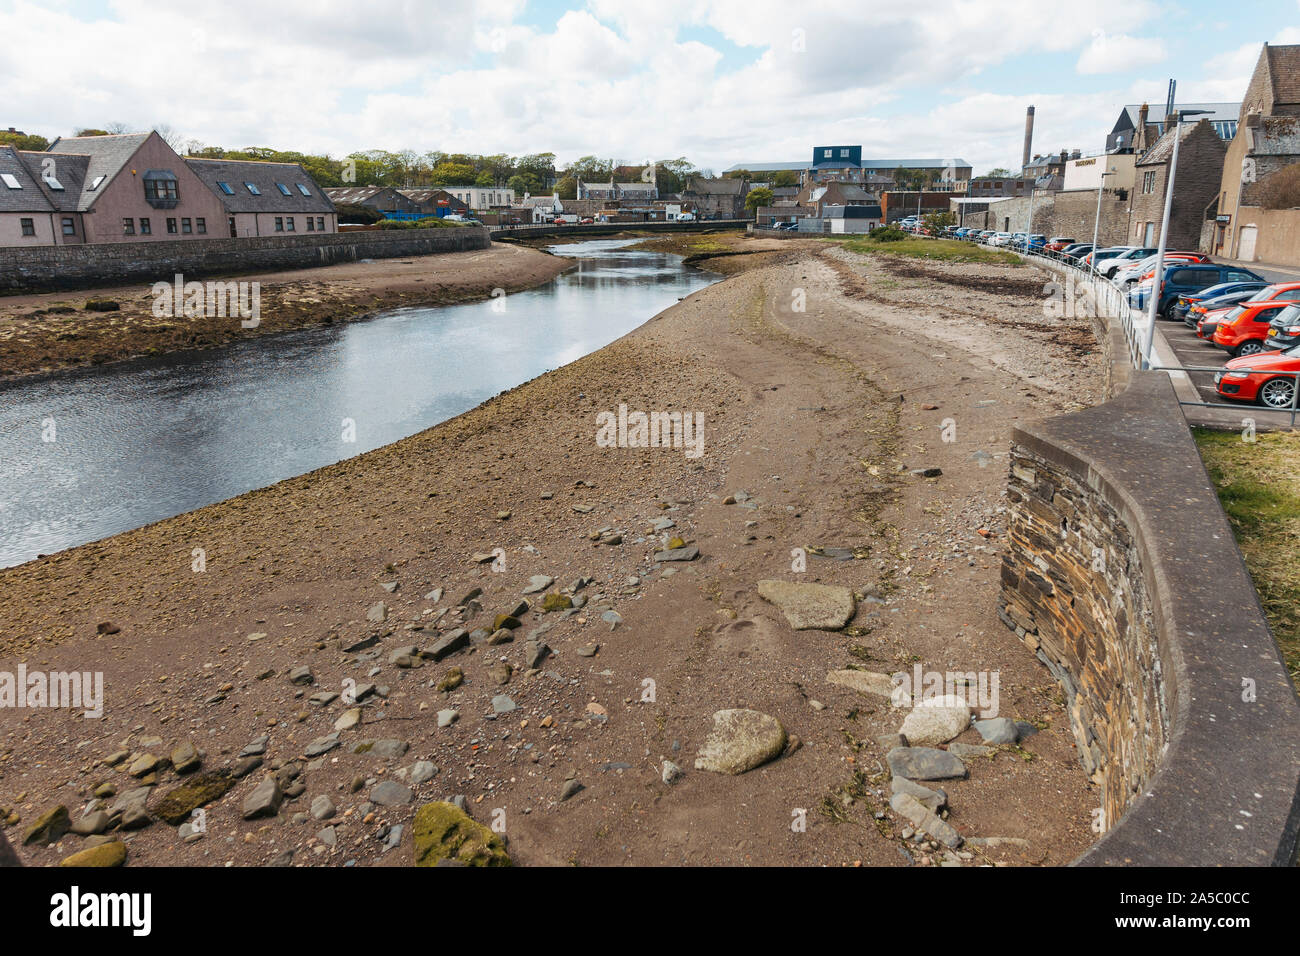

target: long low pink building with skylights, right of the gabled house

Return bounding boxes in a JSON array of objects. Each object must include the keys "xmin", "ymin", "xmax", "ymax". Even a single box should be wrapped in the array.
[{"xmin": 185, "ymin": 157, "xmax": 338, "ymax": 239}]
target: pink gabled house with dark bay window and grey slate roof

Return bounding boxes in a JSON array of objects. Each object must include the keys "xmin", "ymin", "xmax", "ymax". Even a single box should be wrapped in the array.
[{"xmin": 32, "ymin": 133, "xmax": 226, "ymax": 246}]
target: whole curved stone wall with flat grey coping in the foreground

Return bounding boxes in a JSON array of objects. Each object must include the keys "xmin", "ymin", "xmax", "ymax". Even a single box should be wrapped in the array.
[{"xmin": 1001, "ymin": 267, "xmax": 1300, "ymax": 866}]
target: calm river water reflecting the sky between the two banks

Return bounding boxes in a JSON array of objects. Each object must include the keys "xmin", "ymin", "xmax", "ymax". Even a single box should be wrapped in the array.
[{"xmin": 0, "ymin": 239, "xmax": 716, "ymax": 567}]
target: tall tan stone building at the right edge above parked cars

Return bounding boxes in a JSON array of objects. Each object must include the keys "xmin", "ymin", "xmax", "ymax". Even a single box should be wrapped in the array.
[{"xmin": 1204, "ymin": 43, "xmax": 1300, "ymax": 264}]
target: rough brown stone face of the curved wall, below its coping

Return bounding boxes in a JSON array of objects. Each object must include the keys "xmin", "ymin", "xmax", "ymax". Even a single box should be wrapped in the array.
[{"xmin": 1001, "ymin": 444, "xmax": 1169, "ymax": 829}]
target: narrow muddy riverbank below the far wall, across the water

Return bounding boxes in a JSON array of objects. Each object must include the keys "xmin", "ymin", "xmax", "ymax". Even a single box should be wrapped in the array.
[{"xmin": 0, "ymin": 242, "xmax": 573, "ymax": 382}]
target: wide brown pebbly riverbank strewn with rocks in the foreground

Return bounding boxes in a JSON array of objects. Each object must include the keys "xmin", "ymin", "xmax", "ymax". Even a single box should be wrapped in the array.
[{"xmin": 0, "ymin": 245, "xmax": 1102, "ymax": 865}]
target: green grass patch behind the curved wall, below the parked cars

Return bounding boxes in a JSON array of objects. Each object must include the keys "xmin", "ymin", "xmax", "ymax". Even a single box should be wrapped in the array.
[{"xmin": 1192, "ymin": 428, "xmax": 1300, "ymax": 680}]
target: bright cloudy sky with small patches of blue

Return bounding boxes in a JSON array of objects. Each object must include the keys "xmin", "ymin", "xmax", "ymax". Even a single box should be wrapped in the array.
[{"xmin": 0, "ymin": 0, "xmax": 1300, "ymax": 173}]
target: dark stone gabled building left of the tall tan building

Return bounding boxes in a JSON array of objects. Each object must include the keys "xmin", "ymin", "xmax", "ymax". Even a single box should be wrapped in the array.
[{"xmin": 1128, "ymin": 120, "xmax": 1227, "ymax": 250}]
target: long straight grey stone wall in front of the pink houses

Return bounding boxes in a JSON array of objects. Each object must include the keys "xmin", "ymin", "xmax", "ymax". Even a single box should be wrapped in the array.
[{"xmin": 0, "ymin": 226, "xmax": 490, "ymax": 291}]
